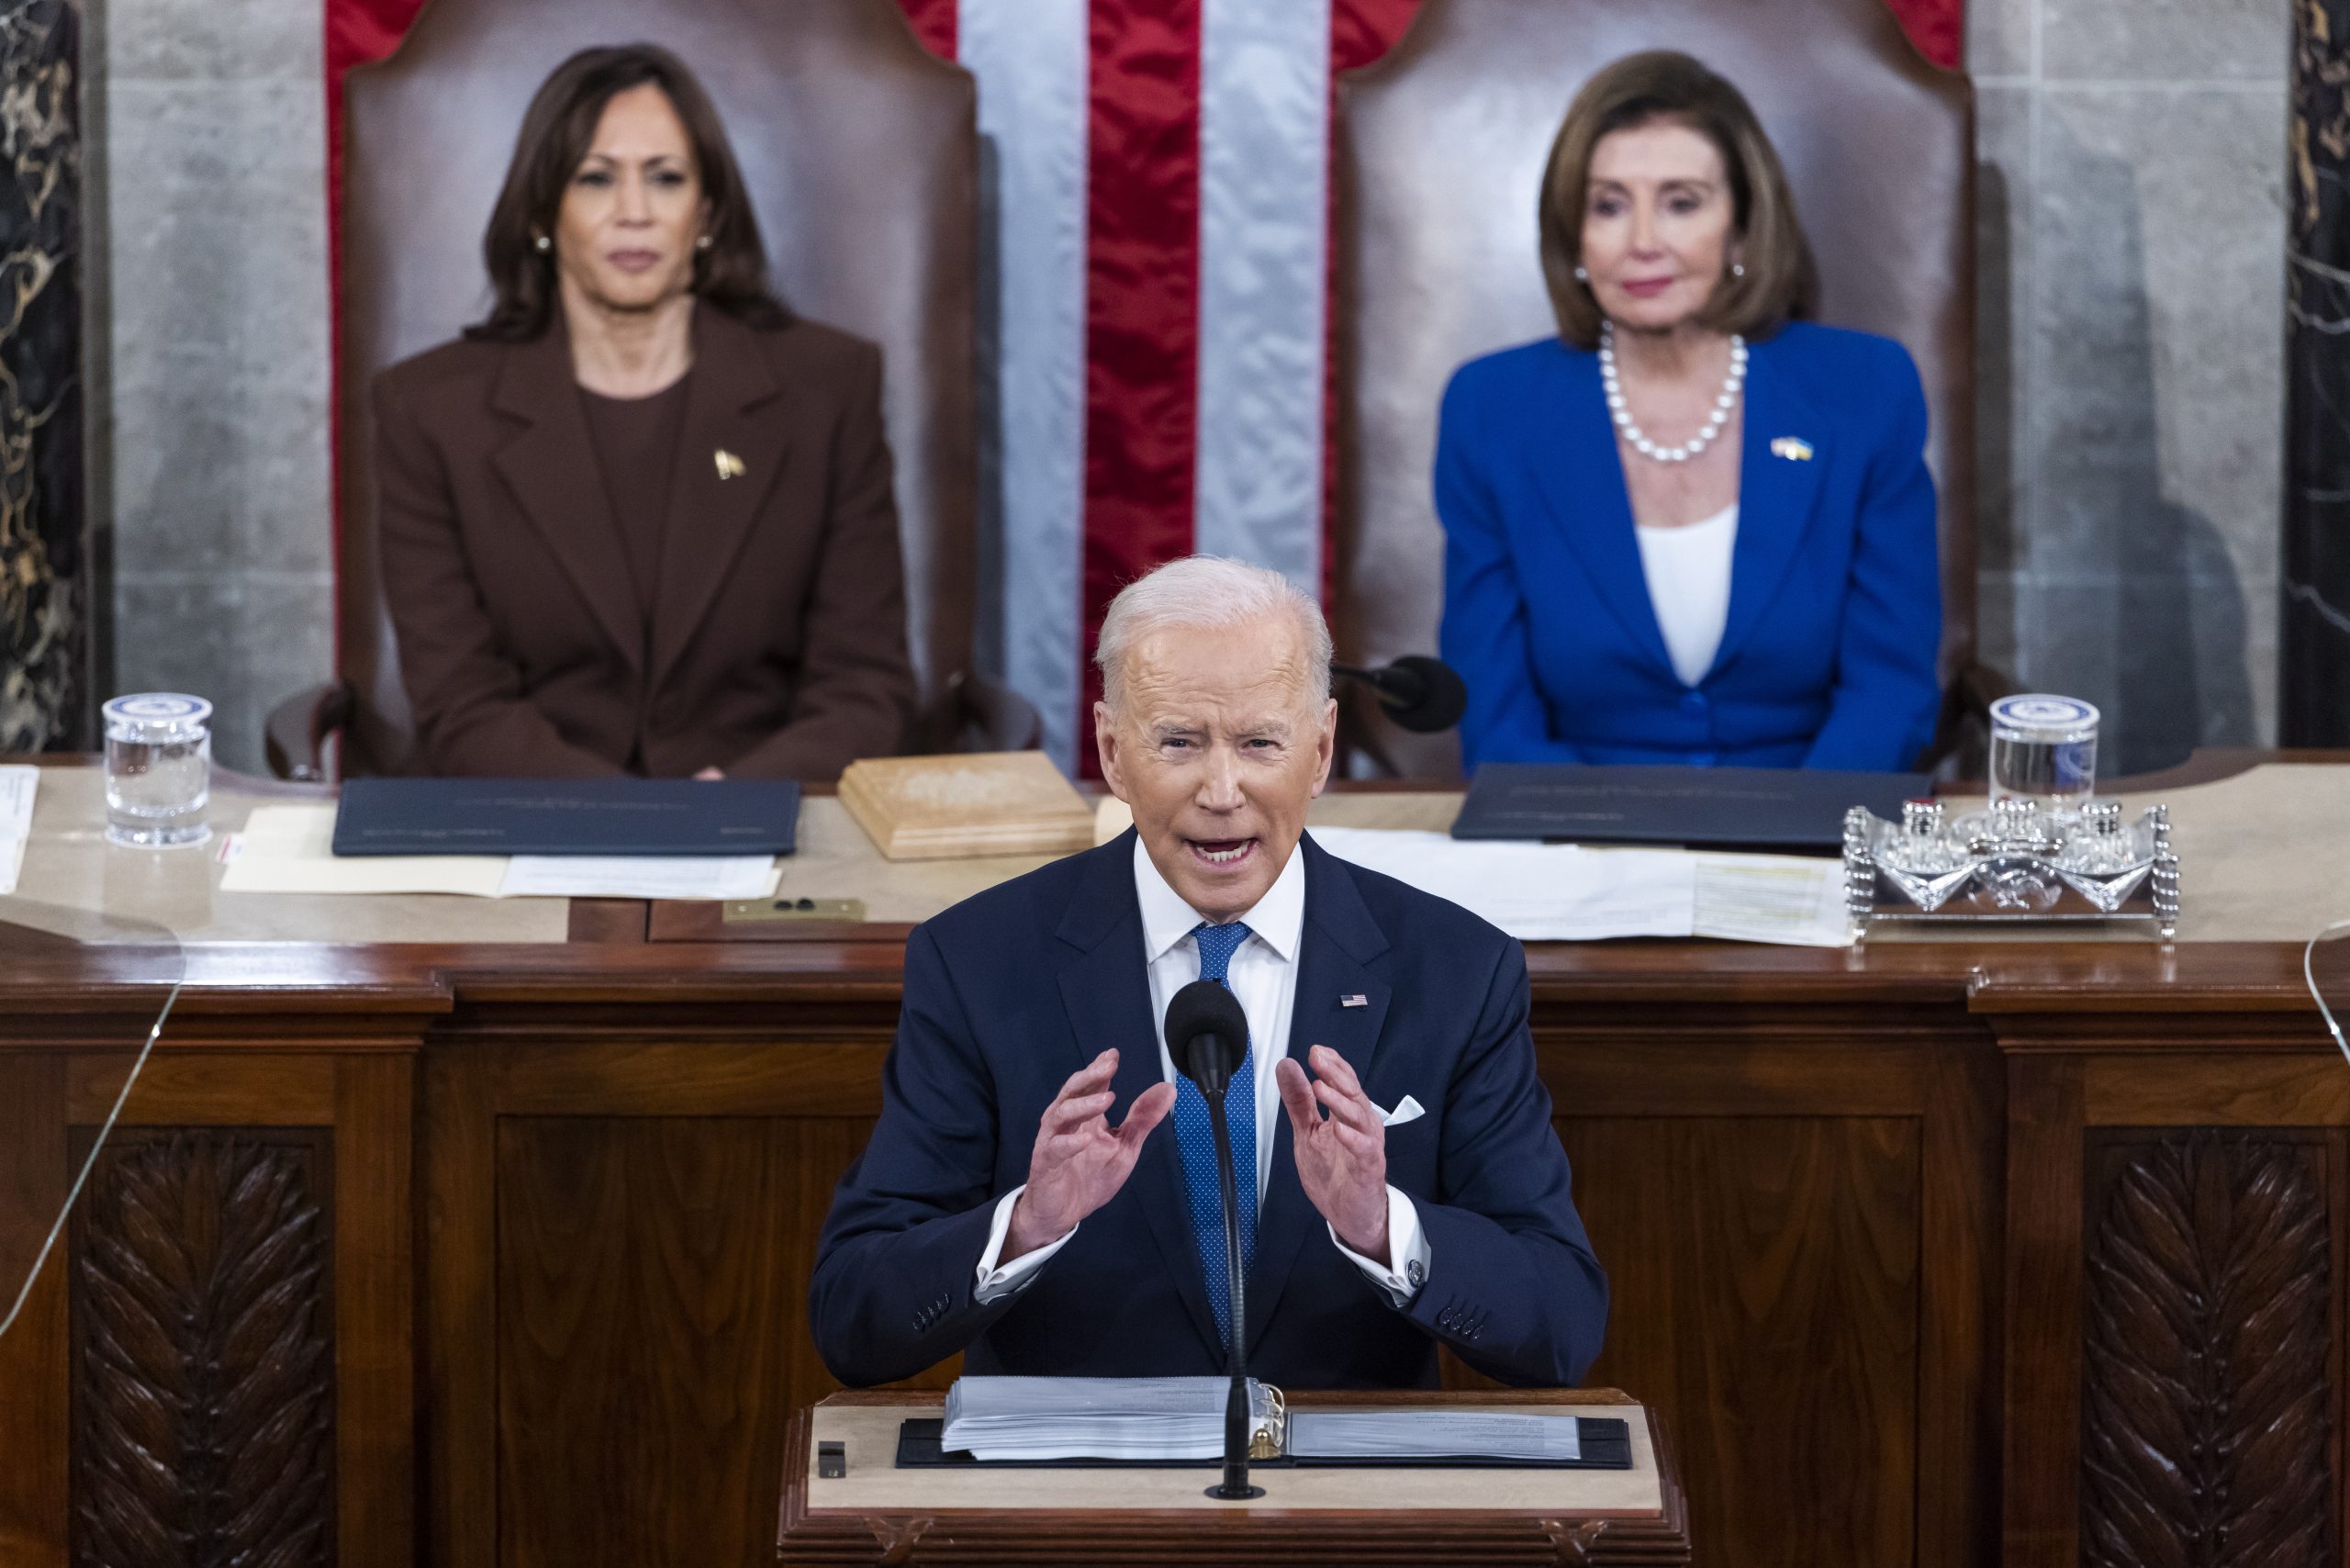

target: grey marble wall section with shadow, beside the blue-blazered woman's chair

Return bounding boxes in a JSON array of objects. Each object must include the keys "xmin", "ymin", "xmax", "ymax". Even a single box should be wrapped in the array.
[{"xmin": 1967, "ymin": 0, "xmax": 2291, "ymax": 771}]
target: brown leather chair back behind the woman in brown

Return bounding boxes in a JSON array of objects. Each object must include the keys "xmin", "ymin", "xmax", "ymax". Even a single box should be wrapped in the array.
[{"xmin": 336, "ymin": 0, "xmax": 980, "ymax": 773}]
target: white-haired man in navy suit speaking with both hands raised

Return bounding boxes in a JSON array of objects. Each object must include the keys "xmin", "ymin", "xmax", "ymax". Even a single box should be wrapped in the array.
[{"xmin": 809, "ymin": 557, "xmax": 1607, "ymax": 1387}]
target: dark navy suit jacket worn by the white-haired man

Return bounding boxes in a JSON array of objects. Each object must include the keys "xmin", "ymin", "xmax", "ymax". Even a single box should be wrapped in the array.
[{"xmin": 809, "ymin": 832, "xmax": 1607, "ymax": 1389}]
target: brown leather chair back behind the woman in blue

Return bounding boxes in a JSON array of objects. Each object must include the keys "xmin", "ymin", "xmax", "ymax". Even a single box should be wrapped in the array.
[{"xmin": 1333, "ymin": 0, "xmax": 1974, "ymax": 778}]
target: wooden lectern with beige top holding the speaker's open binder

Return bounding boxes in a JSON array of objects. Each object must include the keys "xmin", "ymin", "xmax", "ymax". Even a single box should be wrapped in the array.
[{"xmin": 776, "ymin": 1389, "xmax": 1690, "ymax": 1568}]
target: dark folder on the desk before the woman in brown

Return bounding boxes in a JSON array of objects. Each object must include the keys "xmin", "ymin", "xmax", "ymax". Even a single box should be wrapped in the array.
[{"xmin": 334, "ymin": 778, "xmax": 799, "ymax": 856}]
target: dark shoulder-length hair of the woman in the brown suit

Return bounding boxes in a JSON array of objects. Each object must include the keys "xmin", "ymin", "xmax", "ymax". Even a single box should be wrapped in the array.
[{"xmin": 465, "ymin": 45, "xmax": 792, "ymax": 343}]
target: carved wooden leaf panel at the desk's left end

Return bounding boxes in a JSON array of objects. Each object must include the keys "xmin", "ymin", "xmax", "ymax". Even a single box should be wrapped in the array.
[{"xmin": 73, "ymin": 1131, "xmax": 334, "ymax": 1568}]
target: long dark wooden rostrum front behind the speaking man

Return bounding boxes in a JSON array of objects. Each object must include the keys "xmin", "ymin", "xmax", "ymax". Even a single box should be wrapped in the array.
[{"xmin": 0, "ymin": 752, "xmax": 2350, "ymax": 1568}]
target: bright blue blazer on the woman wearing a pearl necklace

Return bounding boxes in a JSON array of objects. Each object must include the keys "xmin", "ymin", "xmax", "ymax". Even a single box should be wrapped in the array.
[{"xmin": 1436, "ymin": 322, "xmax": 1942, "ymax": 771}]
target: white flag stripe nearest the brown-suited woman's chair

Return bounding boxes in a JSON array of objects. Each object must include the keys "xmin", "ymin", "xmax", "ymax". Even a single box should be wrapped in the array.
[{"xmin": 954, "ymin": 0, "xmax": 1092, "ymax": 771}]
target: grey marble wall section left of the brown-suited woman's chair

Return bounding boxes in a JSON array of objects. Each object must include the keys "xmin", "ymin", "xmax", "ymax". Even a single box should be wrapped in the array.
[{"xmin": 92, "ymin": 0, "xmax": 334, "ymax": 771}]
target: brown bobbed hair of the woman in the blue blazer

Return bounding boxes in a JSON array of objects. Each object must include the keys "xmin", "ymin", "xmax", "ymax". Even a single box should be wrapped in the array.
[{"xmin": 1539, "ymin": 50, "xmax": 1818, "ymax": 348}]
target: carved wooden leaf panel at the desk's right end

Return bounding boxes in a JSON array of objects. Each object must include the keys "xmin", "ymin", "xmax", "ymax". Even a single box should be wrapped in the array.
[{"xmin": 2080, "ymin": 1128, "xmax": 2333, "ymax": 1568}]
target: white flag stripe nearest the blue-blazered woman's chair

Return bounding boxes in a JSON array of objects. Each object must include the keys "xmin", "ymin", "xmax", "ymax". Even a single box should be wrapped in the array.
[{"xmin": 1193, "ymin": 0, "xmax": 1330, "ymax": 597}]
